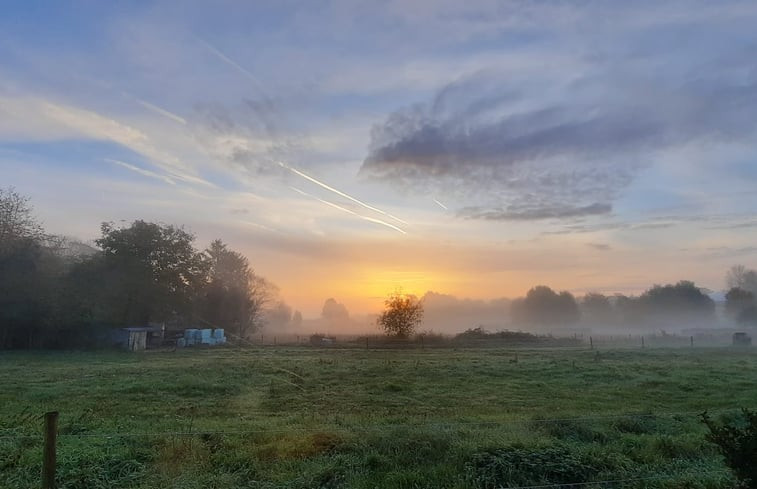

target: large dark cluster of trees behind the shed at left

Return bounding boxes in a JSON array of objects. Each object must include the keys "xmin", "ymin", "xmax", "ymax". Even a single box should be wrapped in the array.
[{"xmin": 0, "ymin": 189, "xmax": 293, "ymax": 349}]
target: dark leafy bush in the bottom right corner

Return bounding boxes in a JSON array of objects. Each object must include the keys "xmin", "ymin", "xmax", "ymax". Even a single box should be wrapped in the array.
[{"xmin": 702, "ymin": 409, "xmax": 757, "ymax": 488}]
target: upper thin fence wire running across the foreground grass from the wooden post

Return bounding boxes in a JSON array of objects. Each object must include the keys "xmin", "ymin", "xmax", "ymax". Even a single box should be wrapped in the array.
[{"xmin": 0, "ymin": 407, "xmax": 743, "ymax": 440}]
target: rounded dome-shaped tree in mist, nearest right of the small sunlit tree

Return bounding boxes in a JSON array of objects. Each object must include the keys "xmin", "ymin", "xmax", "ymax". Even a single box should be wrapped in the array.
[{"xmin": 511, "ymin": 285, "xmax": 581, "ymax": 326}]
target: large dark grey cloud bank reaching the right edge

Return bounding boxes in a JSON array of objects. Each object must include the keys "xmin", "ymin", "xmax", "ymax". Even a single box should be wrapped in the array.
[{"xmin": 361, "ymin": 63, "xmax": 757, "ymax": 220}]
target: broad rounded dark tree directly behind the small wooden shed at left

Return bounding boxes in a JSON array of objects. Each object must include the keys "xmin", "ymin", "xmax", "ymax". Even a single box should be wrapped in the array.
[{"xmin": 96, "ymin": 220, "xmax": 207, "ymax": 325}]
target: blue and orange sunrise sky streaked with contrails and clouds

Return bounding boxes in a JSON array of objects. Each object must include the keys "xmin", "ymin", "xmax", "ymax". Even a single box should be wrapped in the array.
[{"xmin": 0, "ymin": 0, "xmax": 757, "ymax": 317}]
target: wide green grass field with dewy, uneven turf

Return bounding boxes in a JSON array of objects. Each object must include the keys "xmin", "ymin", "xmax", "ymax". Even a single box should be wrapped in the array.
[{"xmin": 0, "ymin": 347, "xmax": 757, "ymax": 488}]
